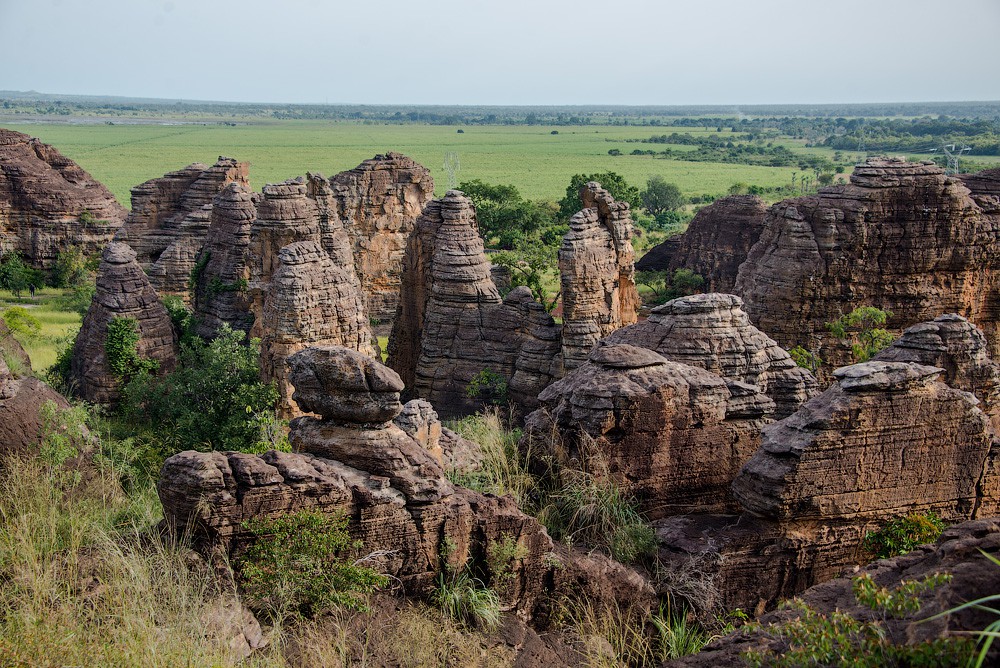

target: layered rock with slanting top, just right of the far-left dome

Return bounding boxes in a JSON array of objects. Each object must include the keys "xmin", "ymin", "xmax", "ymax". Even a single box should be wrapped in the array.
[{"xmin": 115, "ymin": 156, "xmax": 249, "ymax": 280}]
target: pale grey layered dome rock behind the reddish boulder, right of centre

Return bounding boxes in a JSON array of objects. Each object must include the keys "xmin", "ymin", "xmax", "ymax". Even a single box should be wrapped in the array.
[{"xmin": 605, "ymin": 293, "xmax": 818, "ymax": 419}]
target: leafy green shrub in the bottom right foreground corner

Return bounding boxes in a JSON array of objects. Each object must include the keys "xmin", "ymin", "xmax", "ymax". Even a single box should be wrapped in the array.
[{"xmin": 743, "ymin": 573, "xmax": 972, "ymax": 668}]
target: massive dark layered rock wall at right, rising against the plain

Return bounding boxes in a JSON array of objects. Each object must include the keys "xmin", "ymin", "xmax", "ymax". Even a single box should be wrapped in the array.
[{"xmin": 734, "ymin": 158, "xmax": 1000, "ymax": 366}]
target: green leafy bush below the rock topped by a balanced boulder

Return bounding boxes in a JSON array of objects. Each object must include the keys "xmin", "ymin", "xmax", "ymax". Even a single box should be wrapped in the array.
[{"xmin": 235, "ymin": 511, "xmax": 388, "ymax": 621}]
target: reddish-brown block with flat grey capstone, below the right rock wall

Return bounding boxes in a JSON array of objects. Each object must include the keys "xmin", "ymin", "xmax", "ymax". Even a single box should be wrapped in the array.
[{"xmin": 656, "ymin": 362, "xmax": 1000, "ymax": 610}]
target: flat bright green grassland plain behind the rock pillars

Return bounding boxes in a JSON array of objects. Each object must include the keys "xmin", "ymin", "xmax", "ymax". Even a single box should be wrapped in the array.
[{"xmin": 3, "ymin": 121, "xmax": 798, "ymax": 207}]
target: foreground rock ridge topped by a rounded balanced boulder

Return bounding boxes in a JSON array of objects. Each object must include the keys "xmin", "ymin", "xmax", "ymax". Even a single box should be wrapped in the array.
[{"xmin": 158, "ymin": 347, "xmax": 650, "ymax": 616}]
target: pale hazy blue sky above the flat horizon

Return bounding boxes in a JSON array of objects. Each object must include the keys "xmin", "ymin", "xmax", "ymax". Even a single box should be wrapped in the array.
[{"xmin": 0, "ymin": 0, "xmax": 1000, "ymax": 105}]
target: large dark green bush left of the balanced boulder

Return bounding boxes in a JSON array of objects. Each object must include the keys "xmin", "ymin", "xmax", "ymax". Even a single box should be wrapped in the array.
[{"xmin": 121, "ymin": 326, "xmax": 280, "ymax": 453}]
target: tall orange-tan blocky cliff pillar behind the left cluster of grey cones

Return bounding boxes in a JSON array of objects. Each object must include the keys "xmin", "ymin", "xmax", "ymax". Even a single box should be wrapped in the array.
[{"xmin": 330, "ymin": 153, "xmax": 434, "ymax": 322}]
